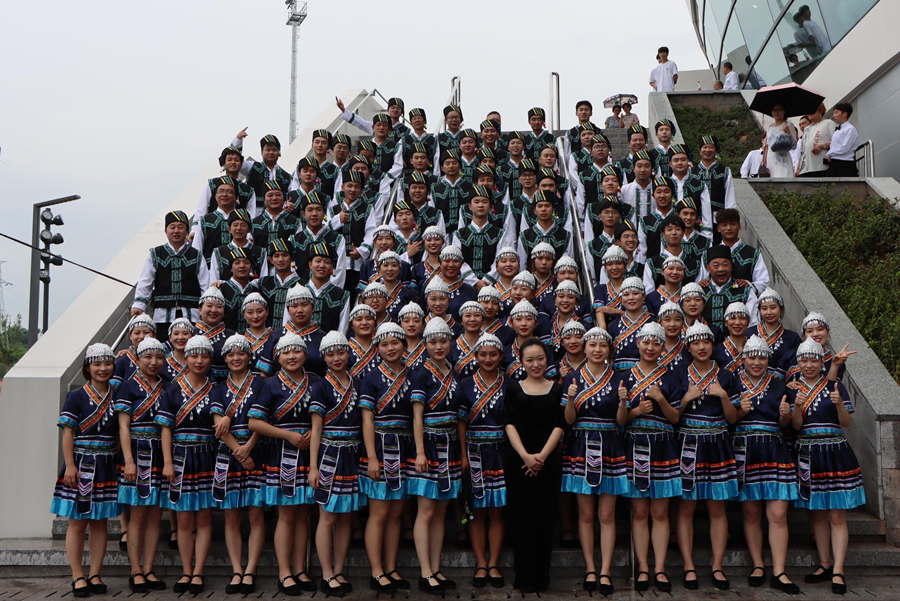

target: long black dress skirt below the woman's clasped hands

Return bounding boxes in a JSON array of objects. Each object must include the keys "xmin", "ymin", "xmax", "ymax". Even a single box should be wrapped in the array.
[{"xmin": 503, "ymin": 448, "xmax": 562, "ymax": 591}]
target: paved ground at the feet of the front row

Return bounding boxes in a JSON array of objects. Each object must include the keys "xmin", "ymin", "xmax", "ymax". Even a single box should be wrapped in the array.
[{"xmin": 0, "ymin": 571, "xmax": 900, "ymax": 601}]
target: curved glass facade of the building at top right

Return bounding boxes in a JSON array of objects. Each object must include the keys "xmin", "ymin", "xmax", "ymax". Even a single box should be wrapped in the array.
[{"xmin": 688, "ymin": 0, "xmax": 880, "ymax": 88}]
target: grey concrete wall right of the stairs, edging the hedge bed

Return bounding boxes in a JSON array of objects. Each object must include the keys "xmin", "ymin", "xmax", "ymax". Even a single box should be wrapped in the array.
[{"xmin": 735, "ymin": 179, "xmax": 900, "ymax": 545}]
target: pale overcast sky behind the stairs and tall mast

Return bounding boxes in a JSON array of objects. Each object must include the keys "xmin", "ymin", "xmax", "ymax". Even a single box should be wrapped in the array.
[{"xmin": 0, "ymin": 0, "xmax": 705, "ymax": 322}]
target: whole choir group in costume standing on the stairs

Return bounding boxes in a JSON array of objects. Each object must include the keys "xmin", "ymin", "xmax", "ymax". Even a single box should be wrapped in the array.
[{"xmin": 52, "ymin": 98, "xmax": 865, "ymax": 597}]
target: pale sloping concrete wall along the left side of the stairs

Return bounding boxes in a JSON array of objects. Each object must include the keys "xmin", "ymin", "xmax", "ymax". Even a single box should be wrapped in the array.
[{"xmin": 0, "ymin": 89, "xmax": 381, "ymax": 538}]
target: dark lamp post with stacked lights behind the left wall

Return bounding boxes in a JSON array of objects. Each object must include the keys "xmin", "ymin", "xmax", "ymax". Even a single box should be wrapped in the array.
[{"xmin": 28, "ymin": 194, "xmax": 81, "ymax": 348}]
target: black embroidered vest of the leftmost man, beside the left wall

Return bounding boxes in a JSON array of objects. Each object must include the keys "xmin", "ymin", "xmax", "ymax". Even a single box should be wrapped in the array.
[{"xmin": 150, "ymin": 244, "xmax": 203, "ymax": 309}]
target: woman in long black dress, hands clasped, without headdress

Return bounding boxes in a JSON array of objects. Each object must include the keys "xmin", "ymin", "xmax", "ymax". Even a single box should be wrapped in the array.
[{"xmin": 503, "ymin": 338, "xmax": 566, "ymax": 593}]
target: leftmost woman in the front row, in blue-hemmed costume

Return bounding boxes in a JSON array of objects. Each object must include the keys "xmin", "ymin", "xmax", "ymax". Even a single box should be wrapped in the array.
[{"xmin": 50, "ymin": 344, "xmax": 119, "ymax": 597}]
